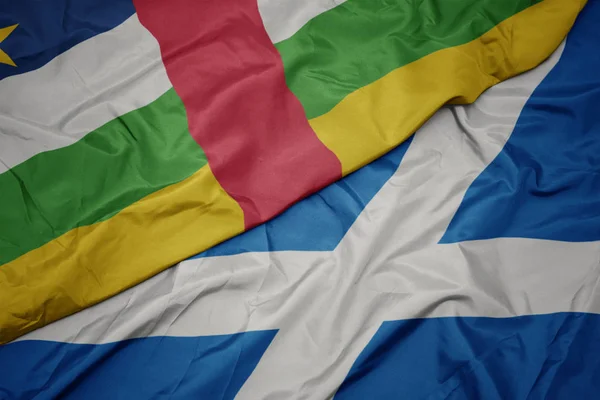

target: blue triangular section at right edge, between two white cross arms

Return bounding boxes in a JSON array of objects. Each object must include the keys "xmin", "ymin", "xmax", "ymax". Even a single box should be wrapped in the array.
[{"xmin": 441, "ymin": 0, "xmax": 600, "ymax": 243}]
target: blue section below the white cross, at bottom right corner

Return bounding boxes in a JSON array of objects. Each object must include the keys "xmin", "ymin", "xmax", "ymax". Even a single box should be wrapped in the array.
[{"xmin": 335, "ymin": 313, "xmax": 600, "ymax": 400}]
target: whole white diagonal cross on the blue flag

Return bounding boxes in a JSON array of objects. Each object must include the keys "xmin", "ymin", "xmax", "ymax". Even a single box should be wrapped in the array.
[{"xmin": 20, "ymin": 42, "xmax": 600, "ymax": 399}]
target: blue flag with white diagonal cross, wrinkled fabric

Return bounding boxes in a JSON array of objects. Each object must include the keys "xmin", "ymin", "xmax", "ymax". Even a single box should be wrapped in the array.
[{"xmin": 0, "ymin": 1, "xmax": 600, "ymax": 399}]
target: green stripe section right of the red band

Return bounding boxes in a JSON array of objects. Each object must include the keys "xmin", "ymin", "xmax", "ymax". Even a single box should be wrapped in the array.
[{"xmin": 275, "ymin": 0, "xmax": 541, "ymax": 119}]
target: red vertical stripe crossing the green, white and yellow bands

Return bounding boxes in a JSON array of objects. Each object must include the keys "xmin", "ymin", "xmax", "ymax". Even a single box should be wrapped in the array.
[{"xmin": 134, "ymin": 0, "xmax": 341, "ymax": 228}]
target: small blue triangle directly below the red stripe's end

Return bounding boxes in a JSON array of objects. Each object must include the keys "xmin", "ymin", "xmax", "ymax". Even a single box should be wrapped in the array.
[{"xmin": 193, "ymin": 137, "xmax": 412, "ymax": 258}]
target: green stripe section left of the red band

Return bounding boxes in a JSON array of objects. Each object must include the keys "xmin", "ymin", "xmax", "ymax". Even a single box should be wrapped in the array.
[{"xmin": 0, "ymin": 89, "xmax": 207, "ymax": 265}]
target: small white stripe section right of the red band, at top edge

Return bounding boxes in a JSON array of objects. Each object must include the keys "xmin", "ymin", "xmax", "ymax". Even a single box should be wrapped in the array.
[{"xmin": 258, "ymin": 0, "xmax": 346, "ymax": 43}]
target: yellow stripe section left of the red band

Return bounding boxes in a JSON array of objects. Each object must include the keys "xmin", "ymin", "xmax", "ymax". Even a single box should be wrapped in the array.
[{"xmin": 0, "ymin": 165, "xmax": 244, "ymax": 343}]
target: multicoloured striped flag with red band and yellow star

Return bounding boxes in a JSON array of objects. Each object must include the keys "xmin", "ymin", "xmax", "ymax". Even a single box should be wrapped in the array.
[{"xmin": 0, "ymin": 0, "xmax": 585, "ymax": 342}]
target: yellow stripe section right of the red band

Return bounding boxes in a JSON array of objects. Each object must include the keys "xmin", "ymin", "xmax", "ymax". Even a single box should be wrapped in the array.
[{"xmin": 310, "ymin": 0, "xmax": 586, "ymax": 175}]
